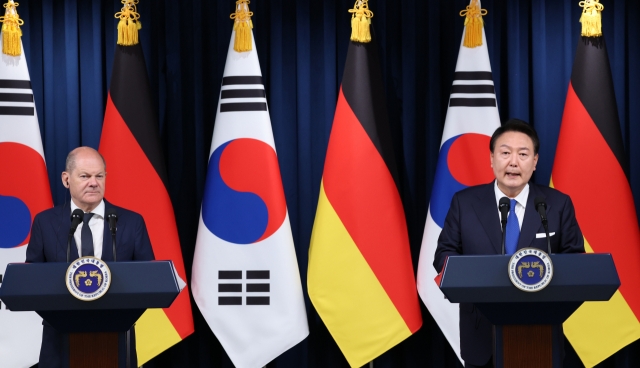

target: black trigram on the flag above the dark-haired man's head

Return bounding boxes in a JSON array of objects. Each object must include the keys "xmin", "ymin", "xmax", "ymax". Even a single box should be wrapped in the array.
[{"xmin": 449, "ymin": 72, "xmax": 496, "ymax": 107}]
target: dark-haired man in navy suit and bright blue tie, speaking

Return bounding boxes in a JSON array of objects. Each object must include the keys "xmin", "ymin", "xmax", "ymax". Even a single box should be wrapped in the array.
[{"xmin": 433, "ymin": 119, "xmax": 584, "ymax": 367}]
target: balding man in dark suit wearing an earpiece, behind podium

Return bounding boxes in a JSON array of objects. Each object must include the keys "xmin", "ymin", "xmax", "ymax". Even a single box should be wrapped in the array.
[{"xmin": 26, "ymin": 147, "xmax": 154, "ymax": 368}]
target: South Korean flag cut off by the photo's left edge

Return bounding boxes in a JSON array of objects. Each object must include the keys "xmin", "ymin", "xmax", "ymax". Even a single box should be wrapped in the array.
[{"xmin": 0, "ymin": 20, "xmax": 52, "ymax": 368}]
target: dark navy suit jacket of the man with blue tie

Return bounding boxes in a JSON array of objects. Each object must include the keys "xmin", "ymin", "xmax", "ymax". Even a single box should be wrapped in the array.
[{"xmin": 433, "ymin": 182, "xmax": 584, "ymax": 366}]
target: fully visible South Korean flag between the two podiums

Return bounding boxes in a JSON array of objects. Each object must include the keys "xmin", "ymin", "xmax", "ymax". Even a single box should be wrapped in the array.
[{"xmin": 191, "ymin": 26, "xmax": 309, "ymax": 368}]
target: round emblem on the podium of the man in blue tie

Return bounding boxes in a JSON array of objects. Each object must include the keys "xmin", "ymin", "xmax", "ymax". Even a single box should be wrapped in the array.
[{"xmin": 509, "ymin": 248, "xmax": 553, "ymax": 292}]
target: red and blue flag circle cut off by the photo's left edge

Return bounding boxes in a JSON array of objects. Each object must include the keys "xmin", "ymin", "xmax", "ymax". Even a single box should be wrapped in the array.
[{"xmin": 0, "ymin": 142, "xmax": 52, "ymax": 248}]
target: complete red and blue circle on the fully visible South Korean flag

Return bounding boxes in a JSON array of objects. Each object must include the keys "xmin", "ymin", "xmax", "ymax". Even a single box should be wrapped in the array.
[{"xmin": 202, "ymin": 138, "xmax": 287, "ymax": 244}]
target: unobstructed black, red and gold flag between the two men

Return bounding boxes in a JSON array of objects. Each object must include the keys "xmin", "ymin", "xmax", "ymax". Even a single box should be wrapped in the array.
[{"xmin": 307, "ymin": 32, "xmax": 422, "ymax": 367}]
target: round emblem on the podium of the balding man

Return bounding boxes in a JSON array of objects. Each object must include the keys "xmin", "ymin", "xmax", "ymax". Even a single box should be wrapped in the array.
[{"xmin": 65, "ymin": 257, "xmax": 111, "ymax": 302}]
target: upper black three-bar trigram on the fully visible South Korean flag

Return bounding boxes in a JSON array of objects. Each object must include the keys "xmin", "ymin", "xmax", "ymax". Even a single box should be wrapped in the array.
[{"xmin": 220, "ymin": 76, "xmax": 267, "ymax": 112}]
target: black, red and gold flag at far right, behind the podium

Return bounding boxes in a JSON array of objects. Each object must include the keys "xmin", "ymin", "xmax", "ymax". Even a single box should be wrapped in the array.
[{"xmin": 551, "ymin": 37, "xmax": 640, "ymax": 367}]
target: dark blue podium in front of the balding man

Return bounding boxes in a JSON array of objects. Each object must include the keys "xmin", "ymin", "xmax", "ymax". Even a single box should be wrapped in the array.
[{"xmin": 0, "ymin": 261, "xmax": 180, "ymax": 368}]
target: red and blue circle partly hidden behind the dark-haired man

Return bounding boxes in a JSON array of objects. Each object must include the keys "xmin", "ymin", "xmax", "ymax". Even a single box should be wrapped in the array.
[{"xmin": 430, "ymin": 133, "xmax": 494, "ymax": 228}]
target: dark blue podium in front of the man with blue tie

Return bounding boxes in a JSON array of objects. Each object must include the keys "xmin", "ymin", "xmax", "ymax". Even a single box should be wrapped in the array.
[{"xmin": 440, "ymin": 253, "xmax": 620, "ymax": 368}]
